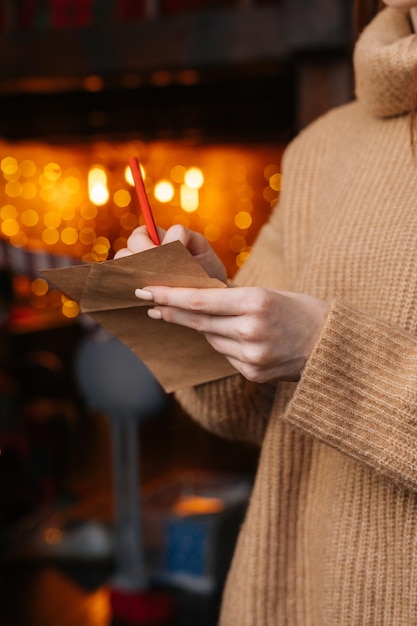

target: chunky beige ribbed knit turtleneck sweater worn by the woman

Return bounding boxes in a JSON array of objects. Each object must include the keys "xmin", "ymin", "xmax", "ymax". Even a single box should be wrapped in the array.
[{"xmin": 178, "ymin": 8, "xmax": 417, "ymax": 626}]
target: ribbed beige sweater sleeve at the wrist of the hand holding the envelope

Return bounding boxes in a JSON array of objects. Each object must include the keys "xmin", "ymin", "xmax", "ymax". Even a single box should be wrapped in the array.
[{"xmin": 285, "ymin": 301, "xmax": 417, "ymax": 490}]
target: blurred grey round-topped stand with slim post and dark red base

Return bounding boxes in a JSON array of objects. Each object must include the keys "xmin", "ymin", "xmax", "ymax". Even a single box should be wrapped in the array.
[{"xmin": 75, "ymin": 328, "xmax": 172, "ymax": 624}]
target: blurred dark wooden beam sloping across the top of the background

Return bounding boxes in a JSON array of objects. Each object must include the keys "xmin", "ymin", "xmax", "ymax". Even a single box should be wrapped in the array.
[{"xmin": 0, "ymin": 0, "xmax": 351, "ymax": 92}]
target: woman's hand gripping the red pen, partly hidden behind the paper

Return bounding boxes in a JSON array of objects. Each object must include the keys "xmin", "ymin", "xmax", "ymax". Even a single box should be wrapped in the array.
[{"xmin": 114, "ymin": 224, "xmax": 227, "ymax": 283}]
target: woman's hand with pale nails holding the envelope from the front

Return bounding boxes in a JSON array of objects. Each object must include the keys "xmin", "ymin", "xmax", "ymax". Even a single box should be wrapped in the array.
[{"xmin": 136, "ymin": 287, "xmax": 328, "ymax": 383}]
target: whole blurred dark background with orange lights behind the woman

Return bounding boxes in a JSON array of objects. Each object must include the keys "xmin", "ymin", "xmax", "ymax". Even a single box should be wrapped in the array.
[{"xmin": 0, "ymin": 0, "xmax": 354, "ymax": 626}]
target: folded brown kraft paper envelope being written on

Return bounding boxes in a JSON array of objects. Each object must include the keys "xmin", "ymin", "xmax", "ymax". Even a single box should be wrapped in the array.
[{"xmin": 41, "ymin": 242, "xmax": 236, "ymax": 393}]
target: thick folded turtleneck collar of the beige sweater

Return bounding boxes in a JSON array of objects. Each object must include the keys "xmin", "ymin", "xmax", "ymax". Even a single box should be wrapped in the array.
[{"xmin": 353, "ymin": 7, "xmax": 417, "ymax": 117}]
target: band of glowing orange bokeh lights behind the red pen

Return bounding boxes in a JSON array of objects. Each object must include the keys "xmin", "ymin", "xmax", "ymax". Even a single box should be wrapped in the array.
[{"xmin": 0, "ymin": 141, "xmax": 281, "ymax": 280}]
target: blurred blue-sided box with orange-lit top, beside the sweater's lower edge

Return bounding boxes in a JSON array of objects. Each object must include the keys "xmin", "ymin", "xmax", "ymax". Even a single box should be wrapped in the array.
[{"xmin": 143, "ymin": 472, "xmax": 252, "ymax": 593}]
